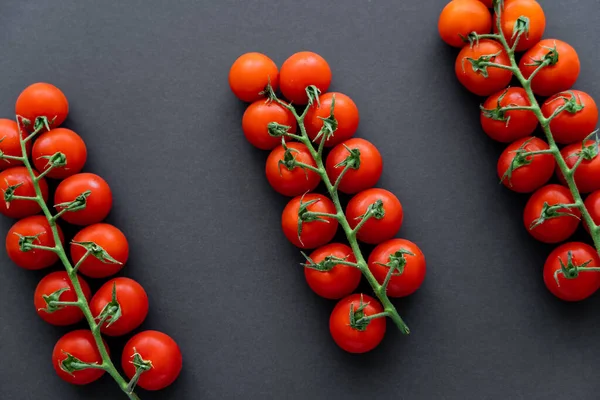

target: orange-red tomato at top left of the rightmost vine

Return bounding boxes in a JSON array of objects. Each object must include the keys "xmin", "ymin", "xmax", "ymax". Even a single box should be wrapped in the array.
[{"xmin": 438, "ymin": 0, "xmax": 492, "ymax": 47}]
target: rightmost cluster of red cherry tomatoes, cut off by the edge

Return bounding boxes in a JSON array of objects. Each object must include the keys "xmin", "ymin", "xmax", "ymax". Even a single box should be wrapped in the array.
[{"xmin": 438, "ymin": 0, "xmax": 600, "ymax": 301}]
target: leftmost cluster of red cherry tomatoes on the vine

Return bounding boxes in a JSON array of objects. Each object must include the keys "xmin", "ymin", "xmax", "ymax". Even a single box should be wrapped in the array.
[{"xmin": 0, "ymin": 83, "xmax": 182, "ymax": 390}]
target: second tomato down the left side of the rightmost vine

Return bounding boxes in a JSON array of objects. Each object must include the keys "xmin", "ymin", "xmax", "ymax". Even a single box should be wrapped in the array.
[{"xmin": 454, "ymin": 39, "xmax": 512, "ymax": 96}]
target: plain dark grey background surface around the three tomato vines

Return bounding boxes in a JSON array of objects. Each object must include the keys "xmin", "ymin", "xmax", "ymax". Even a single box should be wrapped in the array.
[{"xmin": 0, "ymin": 0, "xmax": 600, "ymax": 400}]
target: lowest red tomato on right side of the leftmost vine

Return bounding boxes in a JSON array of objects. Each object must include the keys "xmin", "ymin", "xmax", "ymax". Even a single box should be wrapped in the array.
[{"xmin": 121, "ymin": 331, "xmax": 183, "ymax": 390}]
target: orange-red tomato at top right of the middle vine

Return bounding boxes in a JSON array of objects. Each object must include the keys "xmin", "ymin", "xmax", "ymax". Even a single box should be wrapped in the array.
[{"xmin": 279, "ymin": 51, "xmax": 332, "ymax": 105}]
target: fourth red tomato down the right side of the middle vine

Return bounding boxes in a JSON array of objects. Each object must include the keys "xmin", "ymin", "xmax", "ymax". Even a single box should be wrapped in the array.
[{"xmin": 346, "ymin": 188, "xmax": 404, "ymax": 244}]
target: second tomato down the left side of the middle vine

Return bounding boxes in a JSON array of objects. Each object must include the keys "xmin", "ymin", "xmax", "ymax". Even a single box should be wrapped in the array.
[{"xmin": 242, "ymin": 100, "xmax": 296, "ymax": 150}]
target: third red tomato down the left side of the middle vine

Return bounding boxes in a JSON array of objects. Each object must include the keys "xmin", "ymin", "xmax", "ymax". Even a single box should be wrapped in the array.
[{"xmin": 265, "ymin": 142, "xmax": 321, "ymax": 197}]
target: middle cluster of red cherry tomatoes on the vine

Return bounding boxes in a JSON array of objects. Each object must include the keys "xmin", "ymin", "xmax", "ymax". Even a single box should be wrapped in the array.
[{"xmin": 229, "ymin": 51, "xmax": 425, "ymax": 353}]
